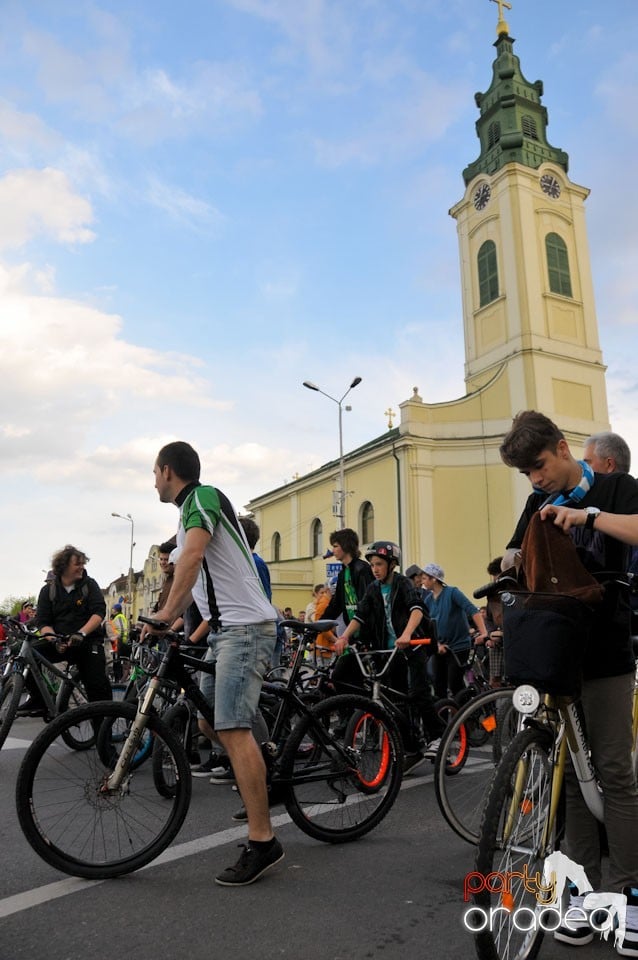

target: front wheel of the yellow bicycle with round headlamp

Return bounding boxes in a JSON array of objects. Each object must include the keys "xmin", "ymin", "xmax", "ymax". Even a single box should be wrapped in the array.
[{"xmin": 468, "ymin": 728, "xmax": 554, "ymax": 960}]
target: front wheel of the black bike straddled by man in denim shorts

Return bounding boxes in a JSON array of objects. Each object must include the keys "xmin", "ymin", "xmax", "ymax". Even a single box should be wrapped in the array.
[{"xmin": 16, "ymin": 701, "xmax": 191, "ymax": 880}]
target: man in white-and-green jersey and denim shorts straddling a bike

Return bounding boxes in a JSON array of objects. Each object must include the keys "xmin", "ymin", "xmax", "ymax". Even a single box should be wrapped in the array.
[{"xmin": 153, "ymin": 441, "xmax": 284, "ymax": 886}]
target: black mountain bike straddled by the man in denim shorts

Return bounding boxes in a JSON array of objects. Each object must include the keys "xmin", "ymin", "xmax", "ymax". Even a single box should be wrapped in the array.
[{"xmin": 16, "ymin": 618, "xmax": 403, "ymax": 879}]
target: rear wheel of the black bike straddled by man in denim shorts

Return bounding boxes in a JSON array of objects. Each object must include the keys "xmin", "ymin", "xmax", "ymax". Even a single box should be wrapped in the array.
[{"xmin": 280, "ymin": 694, "xmax": 403, "ymax": 843}]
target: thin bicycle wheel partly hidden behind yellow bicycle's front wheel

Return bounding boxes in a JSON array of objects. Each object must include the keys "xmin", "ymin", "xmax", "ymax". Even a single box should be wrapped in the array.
[{"xmin": 434, "ymin": 688, "xmax": 518, "ymax": 844}]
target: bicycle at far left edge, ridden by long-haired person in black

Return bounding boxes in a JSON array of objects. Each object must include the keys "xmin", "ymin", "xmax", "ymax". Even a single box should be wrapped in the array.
[{"xmin": 0, "ymin": 623, "xmax": 94, "ymax": 750}]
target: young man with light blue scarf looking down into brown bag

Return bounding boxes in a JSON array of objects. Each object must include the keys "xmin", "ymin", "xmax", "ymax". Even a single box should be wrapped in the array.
[{"xmin": 500, "ymin": 410, "xmax": 638, "ymax": 957}]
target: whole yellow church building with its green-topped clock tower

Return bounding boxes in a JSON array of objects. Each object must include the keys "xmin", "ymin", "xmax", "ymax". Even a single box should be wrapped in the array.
[{"xmin": 244, "ymin": 6, "xmax": 609, "ymax": 613}]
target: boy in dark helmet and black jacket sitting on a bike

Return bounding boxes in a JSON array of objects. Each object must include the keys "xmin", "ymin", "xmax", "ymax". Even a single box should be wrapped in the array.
[{"xmin": 333, "ymin": 540, "xmax": 444, "ymax": 767}]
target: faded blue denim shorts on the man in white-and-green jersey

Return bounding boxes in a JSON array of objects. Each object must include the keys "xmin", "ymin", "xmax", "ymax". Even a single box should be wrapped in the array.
[{"xmin": 199, "ymin": 620, "xmax": 277, "ymax": 730}]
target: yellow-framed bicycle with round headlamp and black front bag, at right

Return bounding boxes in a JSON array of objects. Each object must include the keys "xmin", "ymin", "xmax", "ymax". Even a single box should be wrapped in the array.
[{"xmin": 474, "ymin": 580, "xmax": 638, "ymax": 960}]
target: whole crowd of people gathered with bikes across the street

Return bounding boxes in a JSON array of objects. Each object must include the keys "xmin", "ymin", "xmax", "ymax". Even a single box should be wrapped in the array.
[{"xmin": 3, "ymin": 411, "xmax": 638, "ymax": 956}]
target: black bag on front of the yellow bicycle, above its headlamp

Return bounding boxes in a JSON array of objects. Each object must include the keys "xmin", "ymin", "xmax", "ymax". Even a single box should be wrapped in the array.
[{"xmin": 501, "ymin": 593, "xmax": 592, "ymax": 697}]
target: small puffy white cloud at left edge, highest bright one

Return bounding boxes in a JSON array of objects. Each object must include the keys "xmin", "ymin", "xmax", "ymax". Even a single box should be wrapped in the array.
[{"xmin": 0, "ymin": 167, "xmax": 95, "ymax": 250}]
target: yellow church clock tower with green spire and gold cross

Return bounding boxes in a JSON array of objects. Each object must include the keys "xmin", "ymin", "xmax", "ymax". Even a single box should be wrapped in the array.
[{"xmin": 450, "ymin": 0, "xmax": 608, "ymax": 434}]
